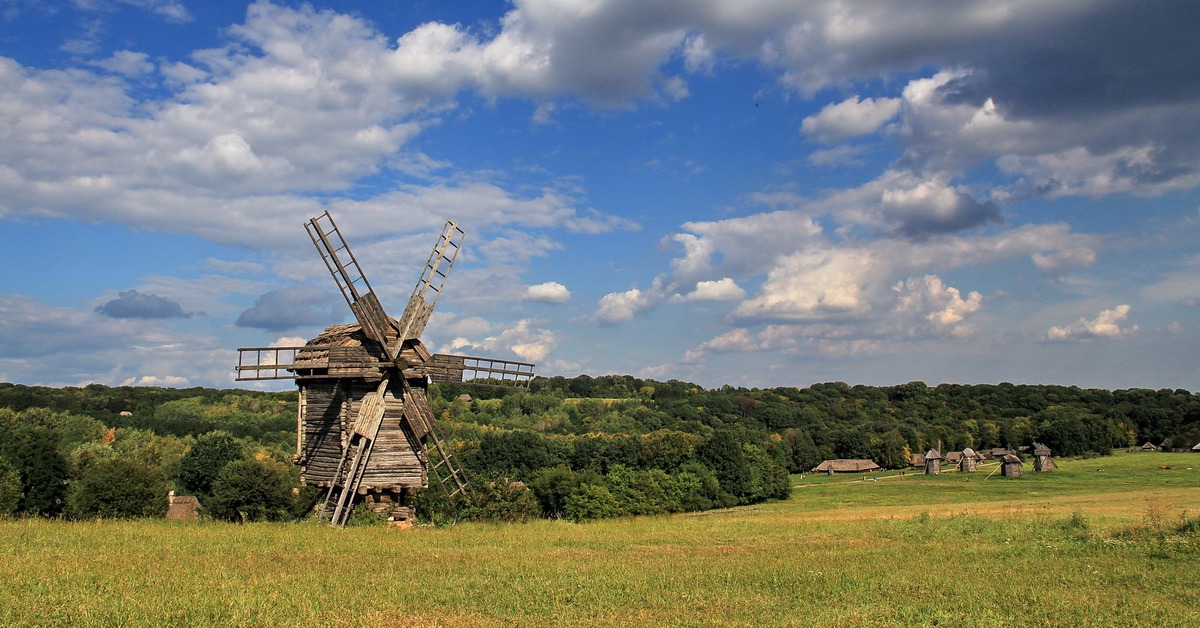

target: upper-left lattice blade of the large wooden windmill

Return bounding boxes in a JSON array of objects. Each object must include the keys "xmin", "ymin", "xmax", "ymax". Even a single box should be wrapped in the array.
[{"xmin": 305, "ymin": 211, "xmax": 392, "ymax": 357}]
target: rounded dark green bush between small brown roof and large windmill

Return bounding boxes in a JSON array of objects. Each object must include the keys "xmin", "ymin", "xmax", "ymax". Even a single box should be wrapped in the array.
[{"xmin": 202, "ymin": 460, "xmax": 295, "ymax": 524}]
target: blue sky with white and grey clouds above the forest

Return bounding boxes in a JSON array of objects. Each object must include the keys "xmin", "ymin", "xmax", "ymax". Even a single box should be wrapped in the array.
[{"xmin": 0, "ymin": 0, "xmax": 1200, "ymax": 390}]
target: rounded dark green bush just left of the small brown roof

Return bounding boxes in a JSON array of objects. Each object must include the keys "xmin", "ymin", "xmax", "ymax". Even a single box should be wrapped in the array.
[{"xmin": 66, "ymin": 457, "xmax": 167, "ymax": 519}]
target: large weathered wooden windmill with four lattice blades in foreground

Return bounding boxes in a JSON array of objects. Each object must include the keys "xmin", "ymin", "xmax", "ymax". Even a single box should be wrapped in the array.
[{"xmin": 236, "ymin": 211, "xmax": 533, "ymax": 526}]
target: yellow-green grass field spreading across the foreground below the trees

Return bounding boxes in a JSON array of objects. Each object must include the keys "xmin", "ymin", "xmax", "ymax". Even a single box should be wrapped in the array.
[{"xmin": 0, "ymin": 454, "xmax": 1200, "ymax": 626}]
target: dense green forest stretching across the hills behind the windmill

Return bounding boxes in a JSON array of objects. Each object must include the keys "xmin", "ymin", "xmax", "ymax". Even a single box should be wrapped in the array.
[{"xmin": 0, "ymin": 375, "xmax": 1200, "ymax": 520}]
